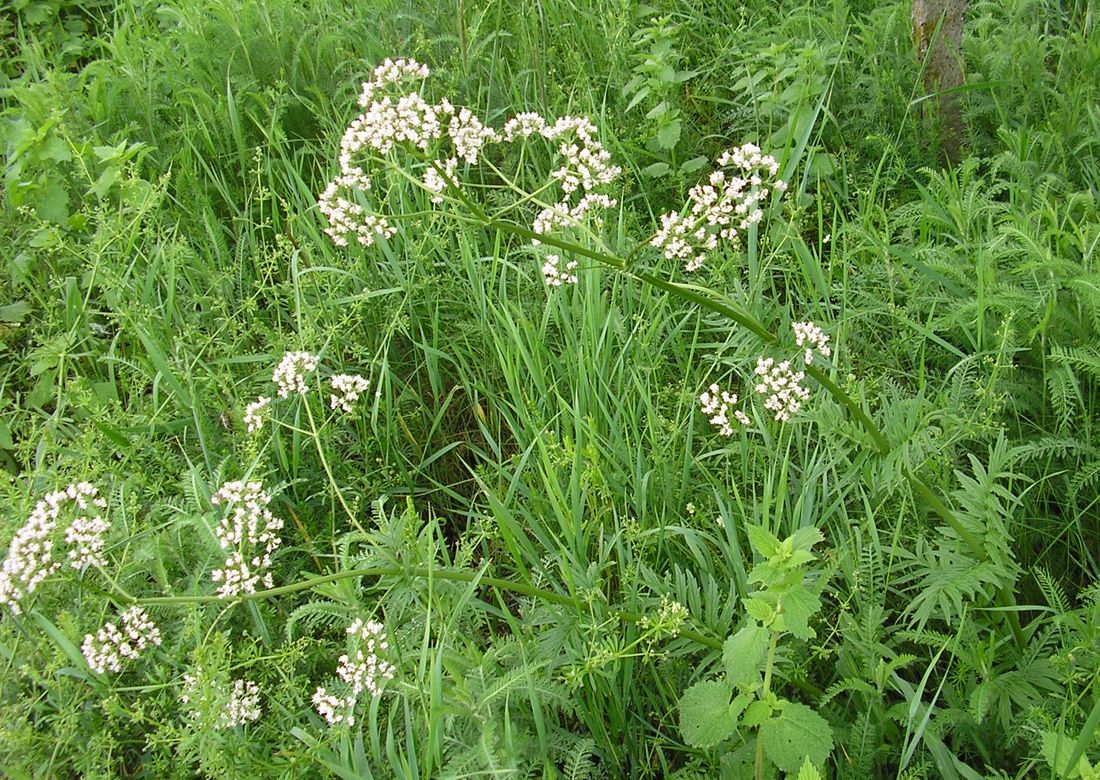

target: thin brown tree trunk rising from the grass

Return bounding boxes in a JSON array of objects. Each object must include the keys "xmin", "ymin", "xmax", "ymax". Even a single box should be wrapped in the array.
[{"xmin": 910, "ymin": 0, "xmax": 968, "ymax": 163}]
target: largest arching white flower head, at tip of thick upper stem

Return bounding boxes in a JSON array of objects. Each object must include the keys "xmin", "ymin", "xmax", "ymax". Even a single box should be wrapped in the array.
[{"xmin": 319, "ymin": 59, "xmax": 622, "ymax": 286}]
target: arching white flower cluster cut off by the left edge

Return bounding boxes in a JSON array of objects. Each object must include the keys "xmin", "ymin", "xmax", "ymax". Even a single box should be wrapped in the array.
[{"xmin": 0, "ymin": 482, "xmax": 110, "ymax": 615}]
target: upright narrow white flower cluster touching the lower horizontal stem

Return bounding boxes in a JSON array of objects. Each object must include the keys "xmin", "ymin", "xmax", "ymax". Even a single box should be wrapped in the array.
[{"xmin": 210, "ymin": 482, "xmax": 283, "ymax": 598}]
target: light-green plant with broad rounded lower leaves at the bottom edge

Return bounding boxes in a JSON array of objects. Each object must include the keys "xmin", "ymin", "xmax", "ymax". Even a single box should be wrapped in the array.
[{"xmin": 680, "ymin": 526, "xmax": 833, "ymax": 780}]
